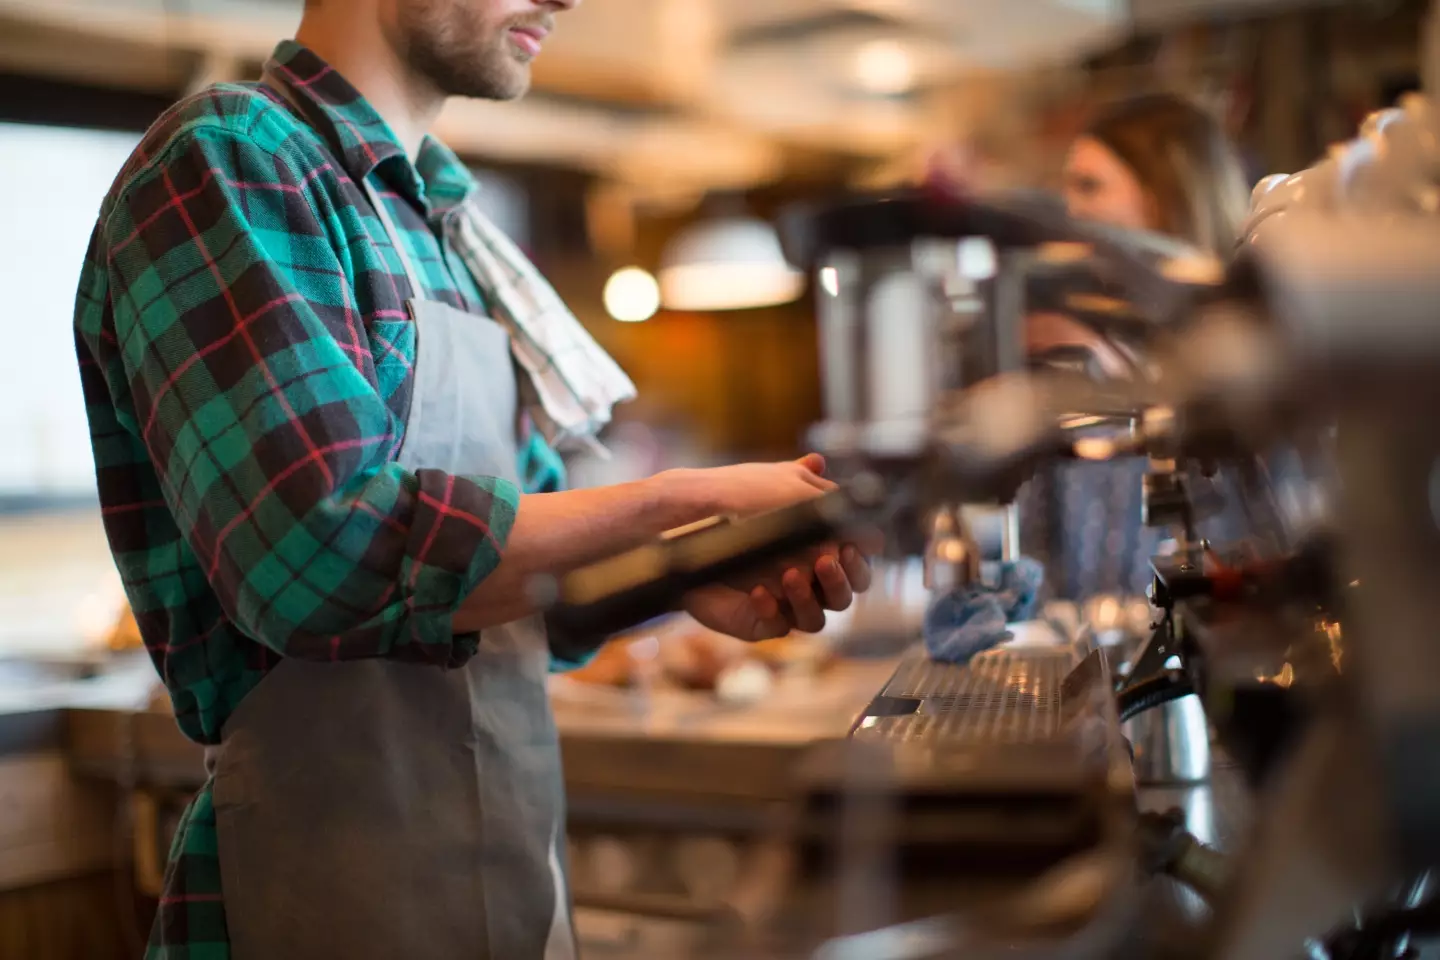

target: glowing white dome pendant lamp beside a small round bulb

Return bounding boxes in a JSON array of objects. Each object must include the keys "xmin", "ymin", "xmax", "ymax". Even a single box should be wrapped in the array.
[{"xmin": 660, "ymin": 217, "xmax": 805, "ymax": 311}]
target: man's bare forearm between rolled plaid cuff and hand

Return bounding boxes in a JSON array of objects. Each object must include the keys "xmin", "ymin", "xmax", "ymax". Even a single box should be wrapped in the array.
[{"xmin": 452, "ymin": 471, "xmax": 716, "ymax": 633}]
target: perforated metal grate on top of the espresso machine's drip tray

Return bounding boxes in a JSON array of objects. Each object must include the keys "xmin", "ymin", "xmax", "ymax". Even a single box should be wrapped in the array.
[{"xmin": 855, "ymin": 649, "xmax": 1077, "ymax": 744}]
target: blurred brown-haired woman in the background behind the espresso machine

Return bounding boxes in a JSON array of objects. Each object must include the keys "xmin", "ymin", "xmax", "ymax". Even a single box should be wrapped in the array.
[{"xmin": 1021, "ymin": 94, "xmax": 1250, "ymax": 600}]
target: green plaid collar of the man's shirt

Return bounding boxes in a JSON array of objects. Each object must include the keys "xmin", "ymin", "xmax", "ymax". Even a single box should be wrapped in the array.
[{"xmin": 266, "ymin": 40, "xmax": 478, "ymax": 214}]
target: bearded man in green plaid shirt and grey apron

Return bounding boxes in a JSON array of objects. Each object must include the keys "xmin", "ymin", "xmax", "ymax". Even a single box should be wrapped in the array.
[{"xmin": 76, "ymin": 0, "xmax": 870, "ymax": 960}]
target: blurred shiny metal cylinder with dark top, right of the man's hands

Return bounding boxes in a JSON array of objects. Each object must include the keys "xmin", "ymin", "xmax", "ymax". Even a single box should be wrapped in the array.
[{"xmin": 780, "ymin": 193, "xmax": 1051, "ymax": 564}]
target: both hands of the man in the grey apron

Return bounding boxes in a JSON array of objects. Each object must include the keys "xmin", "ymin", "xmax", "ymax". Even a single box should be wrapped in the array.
[{"xmin": 671, "ymin": 453, "xmax": 870, "ymax": 640}]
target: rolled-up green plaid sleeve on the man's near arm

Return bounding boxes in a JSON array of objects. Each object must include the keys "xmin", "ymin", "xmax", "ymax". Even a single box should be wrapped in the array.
[{"xmin": 102, "ymin": 128, "xmax": 520, "ymax": 665}]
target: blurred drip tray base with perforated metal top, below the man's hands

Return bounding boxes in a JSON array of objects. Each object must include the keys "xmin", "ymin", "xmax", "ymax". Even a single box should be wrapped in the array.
[{"xmin": 771, "ymin": 645, "xmax": 1135, "ymax": 944}]
